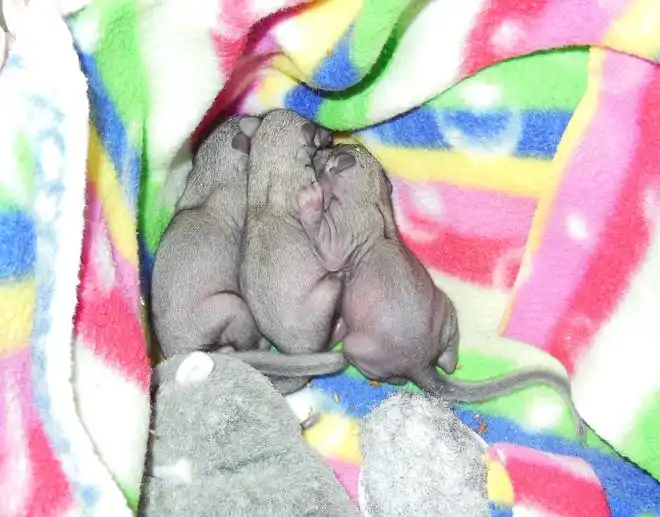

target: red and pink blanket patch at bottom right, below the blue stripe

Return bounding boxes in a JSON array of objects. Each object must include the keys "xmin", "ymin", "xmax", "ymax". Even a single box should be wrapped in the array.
[{"xmin": 488, "ymin": 443, "xmax": 610, "ymax": 517}]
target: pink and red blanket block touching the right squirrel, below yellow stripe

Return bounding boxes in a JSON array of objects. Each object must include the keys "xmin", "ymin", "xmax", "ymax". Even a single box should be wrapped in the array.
[{"xmin": 393, "ymin": 182, "xmax": 534, "ymax": 290}]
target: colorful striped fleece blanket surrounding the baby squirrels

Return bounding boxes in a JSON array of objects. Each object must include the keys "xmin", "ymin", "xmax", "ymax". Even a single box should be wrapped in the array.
[{"xmin": 0, "ymin": 0, "xmax": 660, "ymax": 517}]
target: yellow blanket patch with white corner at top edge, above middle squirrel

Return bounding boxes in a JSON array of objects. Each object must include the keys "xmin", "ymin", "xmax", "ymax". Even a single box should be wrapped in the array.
[{"xmin": 273, "ymin": 0, "xmax": 363, "ymax": 79}]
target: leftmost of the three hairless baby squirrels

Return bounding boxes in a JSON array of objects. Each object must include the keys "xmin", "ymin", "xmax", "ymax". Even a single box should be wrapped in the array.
[{"xmin": 151, "ymin": 117, "xmax": 269, "ymax": 357}]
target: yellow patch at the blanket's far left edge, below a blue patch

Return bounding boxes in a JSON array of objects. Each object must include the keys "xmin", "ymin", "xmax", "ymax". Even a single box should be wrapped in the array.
[{"xmin": 0, "ymin": 279, "xmax": 37, "ymax": 352}]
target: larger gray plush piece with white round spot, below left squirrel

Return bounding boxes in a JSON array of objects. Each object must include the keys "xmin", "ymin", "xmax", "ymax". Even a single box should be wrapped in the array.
[{"xmin": 140, "ymin": 352, "xmax": 360, "ymax": 517}]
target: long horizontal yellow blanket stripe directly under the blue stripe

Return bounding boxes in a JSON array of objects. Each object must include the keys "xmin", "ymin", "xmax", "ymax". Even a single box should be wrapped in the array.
[{"xmin": 365, "ymin": 146, "xmax": 556, "ymax": 198}]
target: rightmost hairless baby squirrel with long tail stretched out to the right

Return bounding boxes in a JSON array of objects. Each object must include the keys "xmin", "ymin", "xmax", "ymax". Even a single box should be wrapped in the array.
[{"xmin": 236, "ymin": 140, "xmax": 585, "ymax": 436}]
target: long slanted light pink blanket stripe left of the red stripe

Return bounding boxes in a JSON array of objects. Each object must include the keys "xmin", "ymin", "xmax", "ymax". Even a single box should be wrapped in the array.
[{"xmin": 505, "ymin": 52, "xmax": 654, "ymax": 349}]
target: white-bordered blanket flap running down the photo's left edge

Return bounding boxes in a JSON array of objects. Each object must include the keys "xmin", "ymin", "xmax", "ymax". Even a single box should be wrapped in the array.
[{"xmin": 0, "ymin": 0, "xmax": 135, "ymax": 517}]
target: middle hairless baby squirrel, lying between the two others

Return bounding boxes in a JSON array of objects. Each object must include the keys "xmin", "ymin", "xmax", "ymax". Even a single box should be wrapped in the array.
[{"xmin": 240, "ymin": 109, "xmax": 346, "ymax": 391}]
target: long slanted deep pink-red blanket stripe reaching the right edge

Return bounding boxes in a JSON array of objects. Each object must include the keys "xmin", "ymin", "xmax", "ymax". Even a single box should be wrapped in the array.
[{"xmin": 550, "ymin": 60, "xmax": 660, "ymax": 372}]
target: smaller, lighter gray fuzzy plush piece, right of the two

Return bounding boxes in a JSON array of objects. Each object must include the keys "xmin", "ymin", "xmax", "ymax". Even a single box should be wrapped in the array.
[{"xmin": 360, "ymin": 392, "xmax": 491, "ymax": 517}]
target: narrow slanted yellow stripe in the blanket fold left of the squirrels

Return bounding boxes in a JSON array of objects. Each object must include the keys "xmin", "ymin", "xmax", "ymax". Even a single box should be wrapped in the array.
[{"xmin": 87, "ymin": 125, "xmax": 138, "ymax": 267}]
